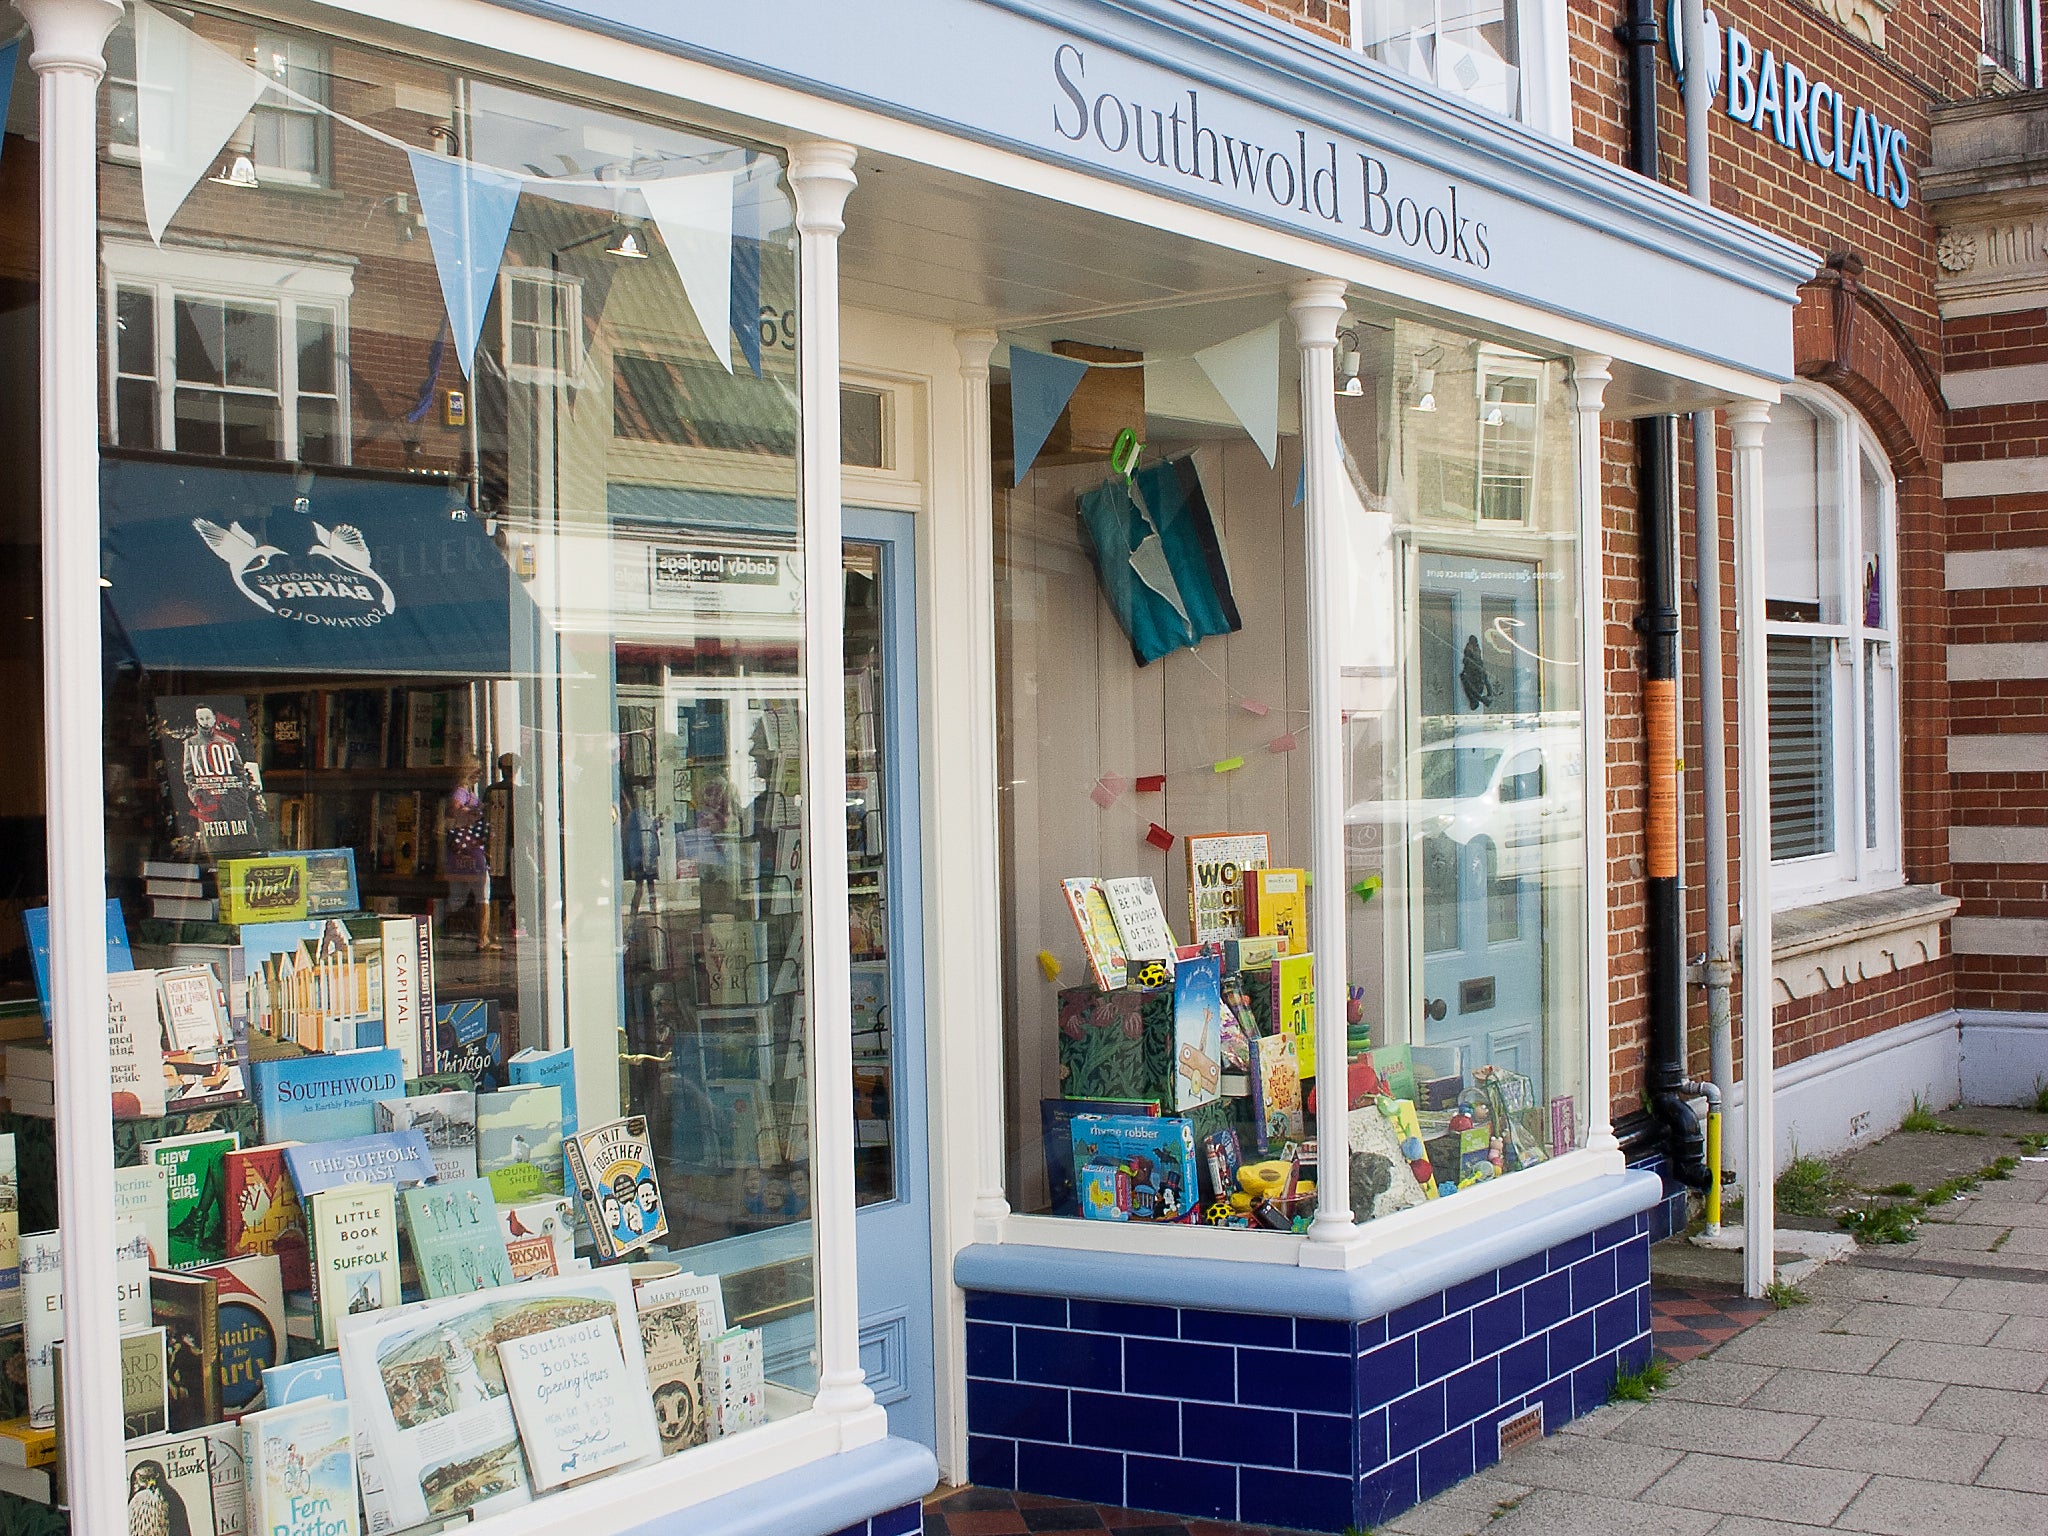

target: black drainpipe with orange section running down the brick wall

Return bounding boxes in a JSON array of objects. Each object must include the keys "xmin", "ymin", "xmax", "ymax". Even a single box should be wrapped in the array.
[{"xmin": 1614, "ymin": 0, "xmax": 1708, "ymax": 1190}]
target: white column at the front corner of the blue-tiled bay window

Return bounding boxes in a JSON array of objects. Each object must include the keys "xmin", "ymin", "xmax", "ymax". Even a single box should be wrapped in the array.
[{"xmin": 1288, "ymin": 276, "xmax": 1356, "ymax": 1262}]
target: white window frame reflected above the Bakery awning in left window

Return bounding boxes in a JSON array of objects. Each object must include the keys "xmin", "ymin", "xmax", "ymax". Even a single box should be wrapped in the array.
[{"xmin": 100, "ymin": 240, "xmax": 354, "ymax": 465}]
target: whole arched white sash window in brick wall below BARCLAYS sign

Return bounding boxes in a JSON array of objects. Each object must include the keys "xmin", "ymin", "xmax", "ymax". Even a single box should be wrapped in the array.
[{"xmin": 1763, "ymin": 391, "xmax": 1898, "ymax": 905}]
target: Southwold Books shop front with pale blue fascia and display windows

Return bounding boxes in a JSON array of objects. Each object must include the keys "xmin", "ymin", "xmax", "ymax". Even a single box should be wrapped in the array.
[{"xmin": 0, "ymin": 0, "xmax": 1812, "ymax": 1536}]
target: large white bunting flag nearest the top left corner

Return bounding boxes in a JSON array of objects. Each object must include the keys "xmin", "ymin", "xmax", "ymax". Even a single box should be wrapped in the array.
[{"xmin": 135, "ymin": 6, "xmax": 270, "ymax": 246}]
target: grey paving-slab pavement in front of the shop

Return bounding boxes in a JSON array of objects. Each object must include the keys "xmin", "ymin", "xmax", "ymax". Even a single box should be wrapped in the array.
[{"xmin": 1378, "ymin": 1110, "xmax": 2048, "ymax": 1536}]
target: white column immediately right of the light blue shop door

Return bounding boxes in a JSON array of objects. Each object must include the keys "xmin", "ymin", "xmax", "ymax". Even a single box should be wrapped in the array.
[{"xmin": 952, "ymin": 330, "xmax": 1010, "ymax": 1243}]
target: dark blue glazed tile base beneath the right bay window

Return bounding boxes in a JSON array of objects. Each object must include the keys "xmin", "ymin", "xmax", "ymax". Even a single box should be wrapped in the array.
[{"xmin": 966, "ymin": 1196, "xmax": 1654, "ymax": 1536}]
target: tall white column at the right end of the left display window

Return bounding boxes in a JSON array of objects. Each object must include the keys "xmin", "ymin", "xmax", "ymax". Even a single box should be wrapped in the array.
[{"xmin": 788, "ymin": 143, "xmax": 879, "ymax": 1441}]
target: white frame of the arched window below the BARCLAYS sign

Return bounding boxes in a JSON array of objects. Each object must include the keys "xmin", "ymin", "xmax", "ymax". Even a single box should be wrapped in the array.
[{"xmin": 1763, "ymin": 385, "xmax": 1905, "ymax": 911}]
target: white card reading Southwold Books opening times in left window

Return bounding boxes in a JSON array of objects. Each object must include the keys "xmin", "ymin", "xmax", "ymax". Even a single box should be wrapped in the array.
[{"xmin": 498, "ymin": 1317, "xmax": 662, "ymax": 1489}]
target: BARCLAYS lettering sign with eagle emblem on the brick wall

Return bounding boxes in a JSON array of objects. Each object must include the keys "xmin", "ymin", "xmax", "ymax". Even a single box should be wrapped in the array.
[{"xmin": 1665, "ymin": 0, "xmax": 1911, "ymax": 209}]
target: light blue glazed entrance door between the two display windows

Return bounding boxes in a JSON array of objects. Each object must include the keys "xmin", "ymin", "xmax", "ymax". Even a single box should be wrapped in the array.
[{"xmin": 846, "ymin": 508, "xmax": 938, "ymax": 1446}]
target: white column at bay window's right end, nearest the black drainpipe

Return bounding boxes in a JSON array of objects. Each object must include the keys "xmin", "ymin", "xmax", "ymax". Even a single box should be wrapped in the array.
[{"xmin": 1571, "ymin": 352, "xmax": 1622, "ymax": 1161}]
